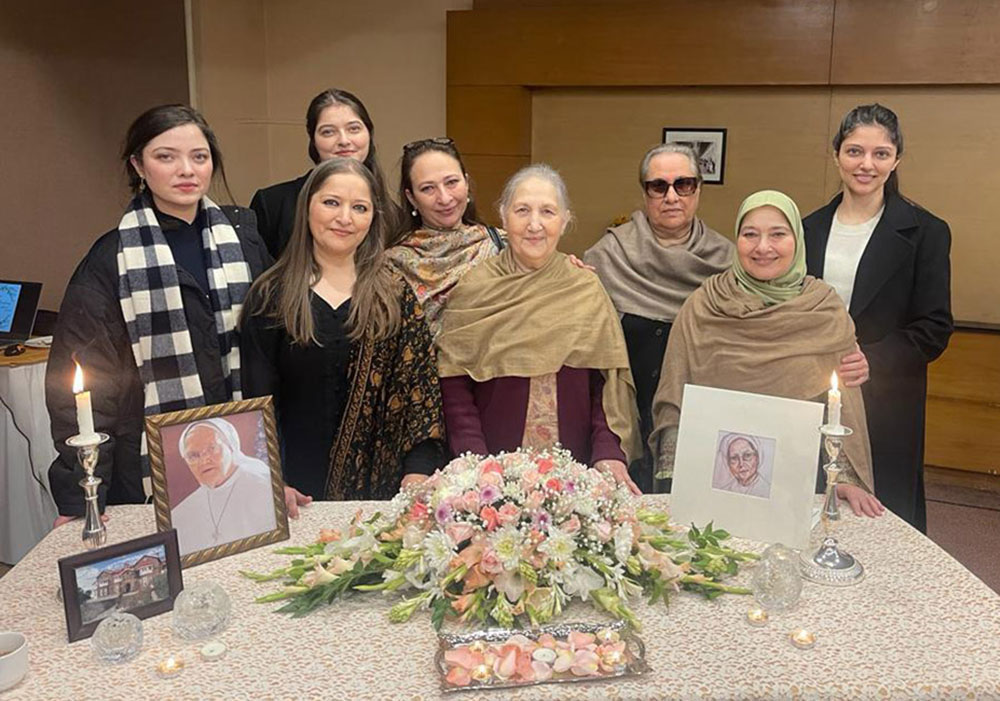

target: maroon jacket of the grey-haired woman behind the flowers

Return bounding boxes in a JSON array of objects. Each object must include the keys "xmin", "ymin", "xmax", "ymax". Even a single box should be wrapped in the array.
[{"xmin": 441, "ymin": 366, "xmax": 625, "ymax": 465}]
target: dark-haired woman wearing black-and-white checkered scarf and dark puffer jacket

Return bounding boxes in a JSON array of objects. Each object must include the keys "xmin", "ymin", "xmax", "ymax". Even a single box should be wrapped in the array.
[{"xmin": 45, "ymin": 105, "xmax": 271, "ymax": 525}]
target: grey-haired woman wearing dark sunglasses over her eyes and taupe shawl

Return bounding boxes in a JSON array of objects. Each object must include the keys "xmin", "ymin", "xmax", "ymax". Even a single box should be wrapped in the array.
[{"xmin": 583, "ymin": 144, "xmax": 733, "ymax": 491}]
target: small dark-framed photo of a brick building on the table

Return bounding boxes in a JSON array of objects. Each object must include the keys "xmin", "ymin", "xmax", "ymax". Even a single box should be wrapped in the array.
[{"xmin": 59, "ymin": 530, "xmax": 184, "ymax": 642}]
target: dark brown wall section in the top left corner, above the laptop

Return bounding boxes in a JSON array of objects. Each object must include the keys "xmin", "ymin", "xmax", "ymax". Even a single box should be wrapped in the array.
[{"xmin": 0, "ymin": 0, "xmax": 188, "ymax": 309}]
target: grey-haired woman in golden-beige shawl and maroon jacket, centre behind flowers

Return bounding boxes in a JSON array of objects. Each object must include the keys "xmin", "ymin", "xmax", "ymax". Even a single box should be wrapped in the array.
[{"xmin": 437, "ymin": 165, "xmax": 639, "ymax": 493}]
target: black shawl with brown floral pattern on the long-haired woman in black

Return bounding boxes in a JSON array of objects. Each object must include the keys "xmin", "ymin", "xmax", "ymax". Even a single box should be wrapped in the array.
[{"xmin": 326, "ymin": 280, "xmax": 444, "ymax": 500}]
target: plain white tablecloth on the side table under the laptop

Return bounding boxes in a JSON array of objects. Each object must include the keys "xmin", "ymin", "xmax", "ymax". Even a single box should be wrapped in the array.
[{"xmin": 0, "ymin": 363, "xmax": 56, "ymax": 564}]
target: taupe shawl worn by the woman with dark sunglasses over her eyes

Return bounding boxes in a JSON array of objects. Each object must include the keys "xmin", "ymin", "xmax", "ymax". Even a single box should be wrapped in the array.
[{"xmin": 583, "ymin": 210, "xmax": 733, "ymax": 321}]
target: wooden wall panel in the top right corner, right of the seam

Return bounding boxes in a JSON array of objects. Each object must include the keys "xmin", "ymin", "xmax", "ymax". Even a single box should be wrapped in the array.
[{"xmin": 830, "ymin": 0, "xmax": 1000, "ymax": 85}]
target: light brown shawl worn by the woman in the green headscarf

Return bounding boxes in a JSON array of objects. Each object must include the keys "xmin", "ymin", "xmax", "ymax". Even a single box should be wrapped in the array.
[{"xmin": 649, "ymin": 270, "xmax": 874, "ymax": 491}]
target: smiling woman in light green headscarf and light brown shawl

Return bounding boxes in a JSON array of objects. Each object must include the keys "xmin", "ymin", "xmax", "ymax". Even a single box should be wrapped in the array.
[{"xmin": 649, "ymin": 190, "xmax": 884, "ymax": 516}]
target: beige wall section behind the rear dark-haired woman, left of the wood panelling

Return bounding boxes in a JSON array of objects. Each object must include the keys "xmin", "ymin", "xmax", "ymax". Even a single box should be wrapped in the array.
[{"xmin": 192, "ymin": 0, "xmax": 472, "ymax": 208}]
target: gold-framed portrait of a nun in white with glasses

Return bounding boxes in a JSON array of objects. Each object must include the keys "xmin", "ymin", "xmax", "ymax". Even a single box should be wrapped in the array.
[{"xmin": 146, "ymin": 397, "xmax": 288, "ymax": 567}]
